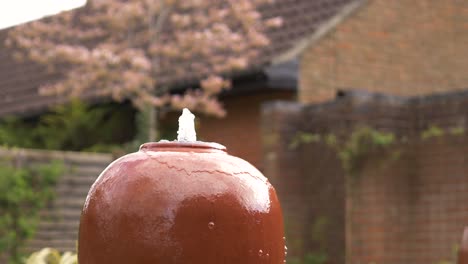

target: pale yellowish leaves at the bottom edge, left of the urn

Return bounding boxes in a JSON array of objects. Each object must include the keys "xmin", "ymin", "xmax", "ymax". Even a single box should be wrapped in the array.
[{"xmin": 25, "ymin": 248, "xmax": 78, "ymax": 264}]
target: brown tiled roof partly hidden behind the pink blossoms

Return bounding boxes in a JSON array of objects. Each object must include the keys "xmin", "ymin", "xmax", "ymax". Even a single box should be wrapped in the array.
[{"xmin": 0, "ymin": 0, "xmax": 356, "ymax": 116}]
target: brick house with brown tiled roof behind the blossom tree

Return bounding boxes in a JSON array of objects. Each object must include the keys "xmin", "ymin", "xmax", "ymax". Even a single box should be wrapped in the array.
[{"xmin": 0, "ymin": 0, "xmax": 352, "ymax": 167}]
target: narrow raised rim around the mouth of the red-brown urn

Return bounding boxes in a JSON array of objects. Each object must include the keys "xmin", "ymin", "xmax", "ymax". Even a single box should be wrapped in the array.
[{"xmin": 140, "ymin": 141, "xmax": 227, "ymax": 153}]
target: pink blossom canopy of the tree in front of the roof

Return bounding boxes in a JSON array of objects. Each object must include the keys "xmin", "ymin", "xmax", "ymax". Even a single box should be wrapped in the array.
[{"xmin": 6, "ymin": 0, "xmax": 282, "ymax": 140}]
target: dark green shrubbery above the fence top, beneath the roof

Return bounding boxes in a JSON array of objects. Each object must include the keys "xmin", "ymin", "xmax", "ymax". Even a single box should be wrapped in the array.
[{"xmin": 0, "ymin": 100, "xmax": 134, "ymax": 152}]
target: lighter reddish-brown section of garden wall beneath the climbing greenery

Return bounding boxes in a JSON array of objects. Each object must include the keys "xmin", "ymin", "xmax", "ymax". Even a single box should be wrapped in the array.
[{"xmin": 347, "ymin": 135, "xmax": 468, "ymax": 264}]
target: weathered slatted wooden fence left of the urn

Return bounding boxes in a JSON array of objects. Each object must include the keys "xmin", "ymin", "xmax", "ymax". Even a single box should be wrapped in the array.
[{"xmin": 0, "ymin": 148, "xmax": 113, "ymax": 252}]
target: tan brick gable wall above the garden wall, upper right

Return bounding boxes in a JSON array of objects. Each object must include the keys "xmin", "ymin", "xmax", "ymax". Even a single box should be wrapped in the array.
[{"xmin": 299, "ymin": 0, "xmax": 468, "ymax": 103}]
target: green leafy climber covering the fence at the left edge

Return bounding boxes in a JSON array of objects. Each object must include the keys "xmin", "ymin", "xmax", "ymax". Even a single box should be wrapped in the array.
[{"xmin": 0, "ymin": 161, "xmax": 63, "ymax": 263}]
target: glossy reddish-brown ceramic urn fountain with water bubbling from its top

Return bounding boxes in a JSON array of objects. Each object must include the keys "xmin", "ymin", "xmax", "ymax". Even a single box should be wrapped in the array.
[{"xmin": 78, "ymin": 110, "xmax": 285, "ymax": 264}]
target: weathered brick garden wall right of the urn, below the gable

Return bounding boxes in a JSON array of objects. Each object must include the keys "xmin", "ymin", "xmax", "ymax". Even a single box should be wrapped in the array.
[{"xmin": 262, "ymin": 92, "xmax": 468, "ymax": 264}]
